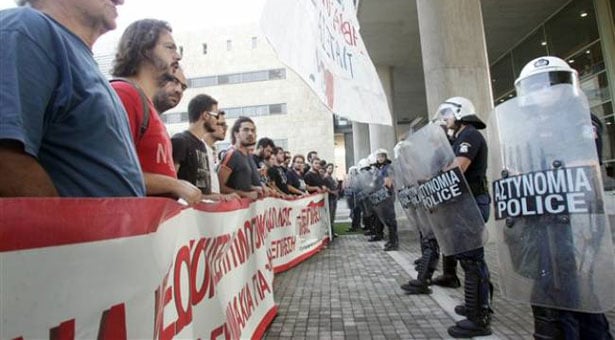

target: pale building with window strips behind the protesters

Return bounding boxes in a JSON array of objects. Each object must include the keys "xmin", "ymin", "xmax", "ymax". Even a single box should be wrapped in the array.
[{"xmin": 96, "ymin": 25, "xmax": 345, "ymax": 171}]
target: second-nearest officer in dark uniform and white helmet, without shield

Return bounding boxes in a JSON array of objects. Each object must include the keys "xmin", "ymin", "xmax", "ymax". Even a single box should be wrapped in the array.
[{"xmin": 438, "ymin": 97, "xmax": 491, "ymax": 337}]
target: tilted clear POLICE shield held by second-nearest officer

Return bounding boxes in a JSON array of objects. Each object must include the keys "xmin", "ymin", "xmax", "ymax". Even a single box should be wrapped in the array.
[{"xmin": 403, "ymin": 124, "xmax": 487, "ymax": 255}]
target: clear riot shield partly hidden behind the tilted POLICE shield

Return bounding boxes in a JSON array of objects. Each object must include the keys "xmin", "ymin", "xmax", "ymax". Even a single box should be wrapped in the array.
[{"xmin": 391, "ymin": 142, "xmax": 435, "ymax": 238}]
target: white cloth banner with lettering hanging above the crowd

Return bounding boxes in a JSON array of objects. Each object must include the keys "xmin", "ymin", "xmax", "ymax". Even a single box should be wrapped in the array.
[{"xmin": 261, "ymin": 0, "xmax": 392, "ymax": 125}]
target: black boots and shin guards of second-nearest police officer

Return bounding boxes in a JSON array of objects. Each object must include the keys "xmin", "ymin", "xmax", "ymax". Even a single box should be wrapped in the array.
[{"xmin": 448, "ymin": 259, "xmax": 491, "ymax": 338}]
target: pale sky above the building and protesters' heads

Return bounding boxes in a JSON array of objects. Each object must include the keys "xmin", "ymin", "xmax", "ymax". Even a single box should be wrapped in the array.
[{"xmin": 0, "ymin": 0, "xmax": 265, "ymax": 51}]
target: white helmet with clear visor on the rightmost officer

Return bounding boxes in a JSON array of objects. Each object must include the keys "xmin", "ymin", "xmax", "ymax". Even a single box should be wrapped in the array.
[{"xmin": 515, "ymin": 56, "xmax": 579, "ymax": 97}]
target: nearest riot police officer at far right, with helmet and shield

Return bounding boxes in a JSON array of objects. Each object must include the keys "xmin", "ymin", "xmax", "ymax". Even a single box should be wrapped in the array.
[{"xmin": 494, "ymin": 57, "xmax": 615, "ymax": 339}]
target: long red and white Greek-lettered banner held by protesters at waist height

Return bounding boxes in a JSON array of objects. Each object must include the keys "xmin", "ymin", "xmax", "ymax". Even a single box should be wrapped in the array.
[{"xmin": 0, "ymin": 195, "xmax": 329, "ymax": 340}]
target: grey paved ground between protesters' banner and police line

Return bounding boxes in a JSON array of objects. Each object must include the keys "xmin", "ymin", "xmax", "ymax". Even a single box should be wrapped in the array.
[{"xmin": 265, "ymin": 202, "xmax": 615, "ymax": 339}]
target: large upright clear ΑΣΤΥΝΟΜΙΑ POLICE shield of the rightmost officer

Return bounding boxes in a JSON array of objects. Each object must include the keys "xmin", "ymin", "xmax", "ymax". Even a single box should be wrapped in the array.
[{"xmin": 489, "ymin": 85, "xmax": 615, "ymax": 313}]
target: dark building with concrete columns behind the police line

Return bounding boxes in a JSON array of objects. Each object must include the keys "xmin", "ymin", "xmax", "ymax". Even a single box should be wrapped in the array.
[{"xmin": 353, "ymin": 0, "xmax": 615, "ymax": 176}]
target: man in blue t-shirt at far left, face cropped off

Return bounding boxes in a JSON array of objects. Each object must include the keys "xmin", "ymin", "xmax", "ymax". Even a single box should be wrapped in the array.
[{"xmin": 0, "ymin": 0, "xmax": 145, "ymax": 197}]
